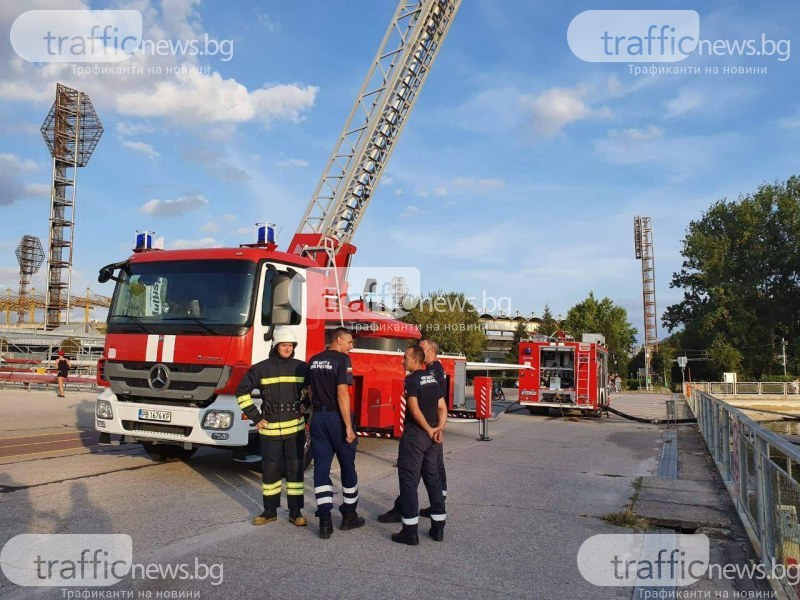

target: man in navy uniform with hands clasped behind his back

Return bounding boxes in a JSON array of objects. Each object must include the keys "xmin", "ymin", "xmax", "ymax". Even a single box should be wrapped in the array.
[{"xmin": 392, "ymin": 346, "xmax": 447, "ymax": 546}]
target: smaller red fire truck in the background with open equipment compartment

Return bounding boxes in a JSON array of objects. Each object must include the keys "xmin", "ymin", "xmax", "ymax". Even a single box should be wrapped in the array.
[{"xmin": 519, "ymin": 331, "xmax": 608, "ymax": 416}]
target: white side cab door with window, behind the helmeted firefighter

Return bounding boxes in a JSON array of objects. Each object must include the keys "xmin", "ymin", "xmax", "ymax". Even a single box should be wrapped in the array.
[{"xmin": 251, "ymin": 263, "xmax": 308, "ymax": 364}]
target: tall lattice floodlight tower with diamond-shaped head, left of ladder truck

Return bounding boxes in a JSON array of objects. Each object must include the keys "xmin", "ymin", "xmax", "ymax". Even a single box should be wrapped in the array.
[{"xmin": 41, "ymin": 83, "xmax": 103, "ymax": 329}]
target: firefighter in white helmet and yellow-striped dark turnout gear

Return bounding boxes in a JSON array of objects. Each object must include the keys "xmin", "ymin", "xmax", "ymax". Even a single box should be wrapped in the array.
[{"xmin": 236, "ymin": 327, "xmax": 308, "ymax": 527}]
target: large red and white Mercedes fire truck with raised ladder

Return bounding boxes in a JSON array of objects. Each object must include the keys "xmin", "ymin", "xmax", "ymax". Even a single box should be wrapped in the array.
[{"xmin": 95, "ymin": 0, "xmax": 466, "ymax": 458}]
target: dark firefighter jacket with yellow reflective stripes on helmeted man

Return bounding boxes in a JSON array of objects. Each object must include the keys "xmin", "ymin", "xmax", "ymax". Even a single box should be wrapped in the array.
[{"xmin": 236, "ymin": 349, "xmax": 308, "ymax": 439}]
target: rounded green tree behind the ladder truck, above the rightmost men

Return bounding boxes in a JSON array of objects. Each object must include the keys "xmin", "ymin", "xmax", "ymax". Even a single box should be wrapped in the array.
[{"xmin": 403, "ymin": 290, "xmax": 486, "ymax": 360}]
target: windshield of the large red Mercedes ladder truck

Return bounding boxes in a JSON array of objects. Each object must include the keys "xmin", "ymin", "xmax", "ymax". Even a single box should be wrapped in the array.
[{"xmin": 108, "ymin": 260, "xmax": 256, "ymax": 335}]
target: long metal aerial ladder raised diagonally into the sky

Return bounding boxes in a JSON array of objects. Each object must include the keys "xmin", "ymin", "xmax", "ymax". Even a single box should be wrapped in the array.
[{"xmin": 289, "ymin": 0, "xmax": 461, "ymax": 282}]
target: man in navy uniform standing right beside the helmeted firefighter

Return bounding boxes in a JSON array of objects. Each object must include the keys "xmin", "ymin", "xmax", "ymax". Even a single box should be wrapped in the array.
[{"xmin": 308, "ymin": 328, "xmax": 364, "ymax": 540}]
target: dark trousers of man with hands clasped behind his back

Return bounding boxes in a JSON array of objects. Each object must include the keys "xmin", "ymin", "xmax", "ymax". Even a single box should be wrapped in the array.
[{"xmin": 397, "ymin": 427, "xmax": 447, "ymax": 530}]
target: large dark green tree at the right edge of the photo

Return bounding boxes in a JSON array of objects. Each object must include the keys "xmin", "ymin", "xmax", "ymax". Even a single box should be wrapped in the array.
[{"xmin": 663, "ymin": 176, "xmax": 800, "ymax": 378}]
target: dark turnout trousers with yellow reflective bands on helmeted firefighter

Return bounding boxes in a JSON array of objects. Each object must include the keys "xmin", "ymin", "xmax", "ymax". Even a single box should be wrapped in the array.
[{"xmin": 259, "ymin": 432, "xmax": 306, "ymax": 514}]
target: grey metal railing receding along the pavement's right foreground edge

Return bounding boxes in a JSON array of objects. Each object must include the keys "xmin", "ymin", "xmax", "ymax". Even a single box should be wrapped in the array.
[{"xmin": 688, "ymin": 392, "xmax": 800, "ymax": 599}]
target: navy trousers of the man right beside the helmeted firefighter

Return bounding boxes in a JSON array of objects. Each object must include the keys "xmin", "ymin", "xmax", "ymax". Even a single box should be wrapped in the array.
[{"xmin": 311, "ymin": 411, "xmax": 358, "ymax": 517}]
